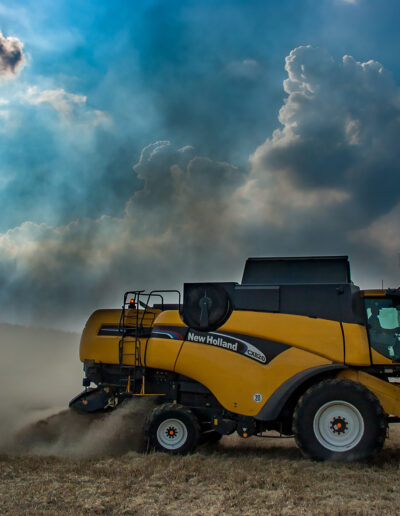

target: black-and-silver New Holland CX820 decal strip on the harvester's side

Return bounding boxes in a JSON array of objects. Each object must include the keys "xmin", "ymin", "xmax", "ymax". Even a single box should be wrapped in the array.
[{"xmin": 186, "ymin": 330, "xmax": 267, "ymax": 364}]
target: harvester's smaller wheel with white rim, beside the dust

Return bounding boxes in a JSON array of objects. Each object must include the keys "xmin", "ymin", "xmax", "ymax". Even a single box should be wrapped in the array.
[{"xmin": 145, "ymin": 403, "xmax": 200, "ymax": 455}]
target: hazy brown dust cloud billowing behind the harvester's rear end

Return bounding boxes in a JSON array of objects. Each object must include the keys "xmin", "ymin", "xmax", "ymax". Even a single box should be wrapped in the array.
[{"xmin": 0, "ymin": 324, "xmax": 152, "ymax": 458}]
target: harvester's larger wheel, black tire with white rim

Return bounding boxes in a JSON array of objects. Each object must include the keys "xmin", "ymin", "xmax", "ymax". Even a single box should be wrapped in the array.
[{"xmin": 293, "ymin": 379, "xmax": 386, "ymax": 461}]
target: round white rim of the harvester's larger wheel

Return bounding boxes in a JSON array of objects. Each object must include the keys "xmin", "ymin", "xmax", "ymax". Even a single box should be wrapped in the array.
[{"xmin": 314, "ymin": 400, "xmax": 364, "ymax": 452}]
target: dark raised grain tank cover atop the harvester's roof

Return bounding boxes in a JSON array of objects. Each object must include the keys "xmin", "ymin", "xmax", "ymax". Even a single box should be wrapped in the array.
[{"xmin": 242, "ymin": 256, "xmax": 351, "ymax": 285}]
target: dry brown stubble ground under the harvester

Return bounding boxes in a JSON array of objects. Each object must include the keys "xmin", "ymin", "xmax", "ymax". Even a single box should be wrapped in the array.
[{"xmin": 0, "ymin": 424, "xmax": 400, "ymax": 515}]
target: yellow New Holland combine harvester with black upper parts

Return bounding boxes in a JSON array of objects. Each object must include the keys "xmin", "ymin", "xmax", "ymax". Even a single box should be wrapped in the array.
[{"xmin": 70, "ymin": 257, "xmax": 400, "ymax": 460}]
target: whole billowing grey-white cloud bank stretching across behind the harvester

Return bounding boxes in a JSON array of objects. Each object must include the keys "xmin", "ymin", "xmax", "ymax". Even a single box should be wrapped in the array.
[{"xmin": 0, "ymin": 47, "xmax": 400, "ymax": 327}]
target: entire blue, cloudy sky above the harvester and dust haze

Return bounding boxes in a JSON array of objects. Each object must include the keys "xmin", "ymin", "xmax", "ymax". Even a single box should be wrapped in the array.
[{"xmin": 0, "ymin": 0, "xmax": 400, "ymax": 330}]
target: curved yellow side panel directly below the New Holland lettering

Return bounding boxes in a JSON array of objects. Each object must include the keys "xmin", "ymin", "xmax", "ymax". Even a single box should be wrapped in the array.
[{"xmin": 175, "ymin": 341, "xmax": 331, "ymax": 416}]
